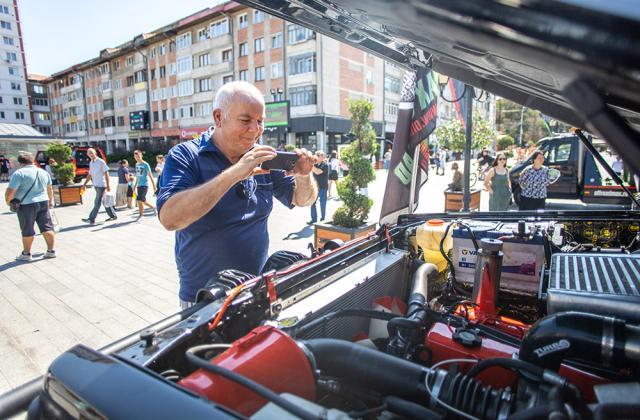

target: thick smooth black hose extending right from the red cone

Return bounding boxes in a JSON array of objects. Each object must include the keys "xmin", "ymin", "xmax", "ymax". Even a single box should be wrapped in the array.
[{"xmin": 299, "ymin": 338, "xmax": 429, "ymax": 402}]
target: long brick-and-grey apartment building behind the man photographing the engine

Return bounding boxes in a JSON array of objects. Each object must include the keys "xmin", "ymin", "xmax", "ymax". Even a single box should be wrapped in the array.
[{"xmin": 47, "ymin": 2, "xmax": 402, "ymax": 152}]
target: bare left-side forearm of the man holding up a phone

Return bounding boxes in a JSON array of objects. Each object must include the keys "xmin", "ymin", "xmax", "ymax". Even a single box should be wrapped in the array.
[{"xmin": 160, "ymin": 170, "xmax": 240, "ymax": 230}]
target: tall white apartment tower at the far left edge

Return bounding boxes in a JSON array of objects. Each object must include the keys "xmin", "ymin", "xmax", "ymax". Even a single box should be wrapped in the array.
[{"xmin": 0, "ymin": 0, "xmax": 32, "ymax": 125}]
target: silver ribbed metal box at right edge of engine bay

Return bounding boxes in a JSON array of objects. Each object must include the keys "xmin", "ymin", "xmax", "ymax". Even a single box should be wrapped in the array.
[{"xmin": 547, "ymin": 254, "xmax": 640, "ymax": 322}]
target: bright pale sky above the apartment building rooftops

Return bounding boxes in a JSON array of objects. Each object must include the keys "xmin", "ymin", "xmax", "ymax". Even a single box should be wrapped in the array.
[{"xmin": 18, "ymin": 0, "xmax": 222, "ymax": 75}]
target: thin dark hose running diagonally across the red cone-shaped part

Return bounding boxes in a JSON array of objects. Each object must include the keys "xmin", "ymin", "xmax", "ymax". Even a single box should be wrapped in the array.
[{"xmin": 185, "ymin": 346, "xmax": 321, "ymax": 420}]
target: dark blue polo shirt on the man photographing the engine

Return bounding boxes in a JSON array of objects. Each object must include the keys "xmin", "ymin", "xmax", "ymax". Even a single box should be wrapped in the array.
[{"xmin": 157, "ymin": 129, "xmax": 294, "ymax": 302}]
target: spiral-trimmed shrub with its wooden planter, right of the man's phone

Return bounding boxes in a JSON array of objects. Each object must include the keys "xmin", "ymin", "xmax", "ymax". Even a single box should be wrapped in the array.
[{"xmin": 315, "ymin": 99, "xmax": 376, "ymax": 248}]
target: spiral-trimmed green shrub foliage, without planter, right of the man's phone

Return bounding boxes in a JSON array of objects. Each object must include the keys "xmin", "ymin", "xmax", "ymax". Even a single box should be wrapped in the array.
[{"xmin": 333, "ymin": 99, "xmax": 376, "ymax": 227}]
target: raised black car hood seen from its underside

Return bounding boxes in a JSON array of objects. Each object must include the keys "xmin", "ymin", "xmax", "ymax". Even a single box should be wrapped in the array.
[{"xmin": 240, "ymin": 0, "xmax": 640, "ymax": 173}]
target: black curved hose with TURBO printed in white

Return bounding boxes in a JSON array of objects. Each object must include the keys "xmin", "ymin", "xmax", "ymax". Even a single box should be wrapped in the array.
[{"xmin": 519, "ymin": 312, "xmax": 640, "ymax": 370}]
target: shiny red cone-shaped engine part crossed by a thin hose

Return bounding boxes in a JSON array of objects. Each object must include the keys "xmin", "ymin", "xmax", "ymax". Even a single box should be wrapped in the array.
[{"xmin": 179, "ymin": 327, "xmax": 316, "ymax": 416}]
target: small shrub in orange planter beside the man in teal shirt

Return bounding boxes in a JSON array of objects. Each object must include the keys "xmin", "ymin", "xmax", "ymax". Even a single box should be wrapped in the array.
[{"xmin": 46, "ymin": 142, "xmax": 82, "ymax": 206}]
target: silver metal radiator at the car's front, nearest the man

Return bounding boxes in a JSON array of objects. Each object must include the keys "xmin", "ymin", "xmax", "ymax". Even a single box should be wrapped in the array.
[{"xmin": 277, "ymin": 250, "xmax": 409, "ymax": 340}]
